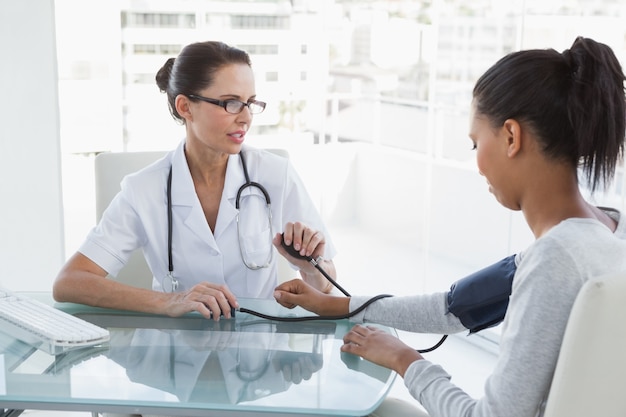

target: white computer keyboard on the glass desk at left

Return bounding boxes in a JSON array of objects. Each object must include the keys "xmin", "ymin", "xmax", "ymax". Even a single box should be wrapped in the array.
[{"xmin": 0, "ymin": 288, "xmax": 110, "ymax": 355}]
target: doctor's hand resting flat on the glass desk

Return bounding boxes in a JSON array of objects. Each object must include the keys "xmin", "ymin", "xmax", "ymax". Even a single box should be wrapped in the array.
[{"xmin": 164, "ymin": 282, "xmax": 239, "ymax": 321}]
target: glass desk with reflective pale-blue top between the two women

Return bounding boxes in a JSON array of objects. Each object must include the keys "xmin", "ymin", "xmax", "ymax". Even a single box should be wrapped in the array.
[{"xmin": 0, "ymin": 293, "xmax": 396, "ymax": 417}]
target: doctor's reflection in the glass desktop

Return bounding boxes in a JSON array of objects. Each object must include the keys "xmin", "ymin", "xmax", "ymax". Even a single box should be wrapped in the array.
[{"xmin": 55, "ymin": 315, "xmax": 335, "ymax": 404}]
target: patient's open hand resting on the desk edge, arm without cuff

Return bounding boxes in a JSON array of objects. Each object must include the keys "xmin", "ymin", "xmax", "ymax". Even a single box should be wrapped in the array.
[{"xmin": 341, "ymin": 324, "xmax": 423, "ymax": 377}]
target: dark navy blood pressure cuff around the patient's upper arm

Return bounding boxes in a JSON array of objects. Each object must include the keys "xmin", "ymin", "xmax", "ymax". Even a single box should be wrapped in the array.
[{"xmin": 448, "ymin": 255, "xmax": 517, "ymax": 333}]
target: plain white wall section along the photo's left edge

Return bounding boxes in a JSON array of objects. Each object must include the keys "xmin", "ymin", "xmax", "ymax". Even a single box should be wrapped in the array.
[{"xmin": 0, "ymin": 0, "xmax": 64, "ymax": 290}]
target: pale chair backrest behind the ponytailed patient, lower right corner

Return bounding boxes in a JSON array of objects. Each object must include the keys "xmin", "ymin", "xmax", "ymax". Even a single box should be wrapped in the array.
[{"xmin": 544, "ymin": 271, "xmax": 626, "ymax": 417}]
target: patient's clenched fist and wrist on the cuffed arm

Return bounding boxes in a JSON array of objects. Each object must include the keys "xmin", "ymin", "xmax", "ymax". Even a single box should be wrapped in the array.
[{"xmin": 274, "ymin": 279, "xmax": 350, "ymax": 316}]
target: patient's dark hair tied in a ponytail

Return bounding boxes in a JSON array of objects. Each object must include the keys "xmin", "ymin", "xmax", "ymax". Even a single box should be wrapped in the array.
[{"xmin": 473, "ymin": 37, "xmax": 626, "ymax": 191}]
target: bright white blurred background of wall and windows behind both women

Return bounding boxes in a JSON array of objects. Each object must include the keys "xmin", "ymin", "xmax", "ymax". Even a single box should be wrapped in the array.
[{"xmin": 0, "ymin": 0, "xmax": 626, "ymax": 376}]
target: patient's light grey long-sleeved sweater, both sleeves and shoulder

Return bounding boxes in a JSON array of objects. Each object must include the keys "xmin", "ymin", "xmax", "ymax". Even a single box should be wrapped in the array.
[{"xmin": 350, "ymin": 211, "xmax": 626, "ymax": 417}]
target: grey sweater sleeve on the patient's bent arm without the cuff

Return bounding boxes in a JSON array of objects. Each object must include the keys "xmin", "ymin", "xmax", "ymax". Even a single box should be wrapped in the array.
[{"xmin": 404, "ymin": 234, "xmax": 584, "ymax": 417}]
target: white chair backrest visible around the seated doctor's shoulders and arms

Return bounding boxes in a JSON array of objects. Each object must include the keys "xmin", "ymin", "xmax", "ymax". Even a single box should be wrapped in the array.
[{"xmin": 94, "ymin": 148, "xmax": 295, "ymax": 288}]
